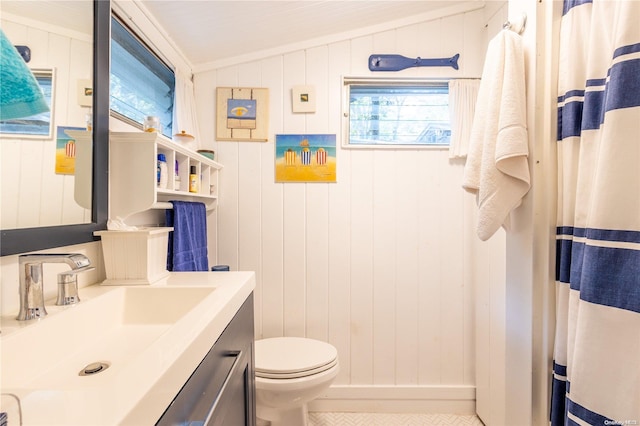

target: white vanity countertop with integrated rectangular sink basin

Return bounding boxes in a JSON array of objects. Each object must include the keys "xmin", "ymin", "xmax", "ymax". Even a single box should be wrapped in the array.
[{"xmin": 0, "ymin": 272, "xmax": 255, "ymax": 425}]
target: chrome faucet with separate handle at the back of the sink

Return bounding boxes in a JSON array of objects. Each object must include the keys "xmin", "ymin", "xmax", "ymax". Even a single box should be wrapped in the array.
[{"xmin": 16, "ymin": 253, "xmax": 94, "ymax": 321}]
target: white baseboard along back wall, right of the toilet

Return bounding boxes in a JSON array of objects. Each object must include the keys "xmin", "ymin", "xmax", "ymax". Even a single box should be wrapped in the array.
[{"xmin": 309, "ymin": 385, "xmax": 476, "ymax": 415}]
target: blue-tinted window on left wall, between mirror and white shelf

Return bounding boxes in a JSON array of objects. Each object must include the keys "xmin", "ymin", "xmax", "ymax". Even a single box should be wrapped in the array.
[{"xmin": 110, "ymin": 17, "xmax": 175, "ymax": 137}]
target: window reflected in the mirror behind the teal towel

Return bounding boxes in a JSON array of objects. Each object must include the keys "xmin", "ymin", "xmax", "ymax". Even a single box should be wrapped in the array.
[{"xmin": 0, "ymin": 69, "xmax": 54, "ymax": 139}]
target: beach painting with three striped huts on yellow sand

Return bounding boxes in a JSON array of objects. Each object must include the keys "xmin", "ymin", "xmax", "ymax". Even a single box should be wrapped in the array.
[{"xmin": 275, "ymin": 134, "xmax": 336, "ymax": 182}]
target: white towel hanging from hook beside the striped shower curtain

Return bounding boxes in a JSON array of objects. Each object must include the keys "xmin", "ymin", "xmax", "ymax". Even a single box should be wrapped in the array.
[{"xmin": 463, "ymin": 31, "xmax": 530, "ymax": 241}]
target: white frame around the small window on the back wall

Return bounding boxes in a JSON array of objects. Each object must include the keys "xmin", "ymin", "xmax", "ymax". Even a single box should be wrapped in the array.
[{"xmin": 341, "ymin": 76, "xmax": 451, "ymax": 151}]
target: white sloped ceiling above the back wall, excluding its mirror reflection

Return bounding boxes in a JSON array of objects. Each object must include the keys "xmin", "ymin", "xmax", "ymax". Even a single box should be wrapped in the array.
[{"xmin": 141, "ymin": 0, "xmax": 482, "ymax": 65}]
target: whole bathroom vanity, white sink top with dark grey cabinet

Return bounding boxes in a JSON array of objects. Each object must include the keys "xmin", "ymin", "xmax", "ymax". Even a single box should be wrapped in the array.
[{"xmin": 0, "ymin": 272, "xmax": 255, "ymax": 425}]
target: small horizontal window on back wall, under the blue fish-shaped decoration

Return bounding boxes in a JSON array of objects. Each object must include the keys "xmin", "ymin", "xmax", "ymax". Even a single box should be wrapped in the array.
[{"xmin": 344, "ymin": 78, "xmax": 451, "ymax": 147}]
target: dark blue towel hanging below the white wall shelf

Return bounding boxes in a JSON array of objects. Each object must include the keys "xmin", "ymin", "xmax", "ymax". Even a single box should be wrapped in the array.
[{"xmin": 166, "ymin": 201, "xmax": 209, "ymax": 271}]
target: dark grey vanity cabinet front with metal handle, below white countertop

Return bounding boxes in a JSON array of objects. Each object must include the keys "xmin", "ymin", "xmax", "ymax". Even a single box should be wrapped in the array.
[{"xmin": 156, "ymin": 295, "xmax": 256, "ymax": 426}]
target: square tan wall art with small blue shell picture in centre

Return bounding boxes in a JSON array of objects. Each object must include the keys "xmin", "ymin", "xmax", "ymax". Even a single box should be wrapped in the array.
[{"xmin": 216, "ymin": 87, "xmax": 269, "ymax": 142}]
